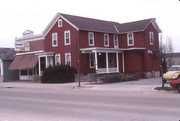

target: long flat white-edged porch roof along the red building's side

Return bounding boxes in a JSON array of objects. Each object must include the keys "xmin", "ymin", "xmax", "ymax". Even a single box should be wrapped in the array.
[{"xmin": 80, "ymin": 47, "xmax": 145, "ymax": 53}]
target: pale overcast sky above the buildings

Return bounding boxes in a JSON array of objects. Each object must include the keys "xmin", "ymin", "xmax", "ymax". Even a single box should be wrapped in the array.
[{"xmin": 0, "ymin": 0, "xmax": 180, "ymax": 52}]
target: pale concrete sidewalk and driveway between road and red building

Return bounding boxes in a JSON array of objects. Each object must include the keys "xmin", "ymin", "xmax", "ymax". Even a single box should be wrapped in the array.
[{"xmin": 0, "ymin": 78, "xmax": 161, "ymax": 91}]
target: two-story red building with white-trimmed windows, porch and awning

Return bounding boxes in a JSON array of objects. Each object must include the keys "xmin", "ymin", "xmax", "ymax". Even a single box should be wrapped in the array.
[{"xmin": 9, "ymin": 13, "xmax": 161, "ymax": 80}]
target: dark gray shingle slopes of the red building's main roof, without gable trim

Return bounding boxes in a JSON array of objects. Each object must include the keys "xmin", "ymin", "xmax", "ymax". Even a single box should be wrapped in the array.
[{"xmin": 59, "ymin": 13, "xmax": 155, "ymax": 33}]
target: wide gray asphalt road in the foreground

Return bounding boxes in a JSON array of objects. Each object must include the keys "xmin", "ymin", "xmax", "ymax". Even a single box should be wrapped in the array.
[{"xmin": 0, "ymin": 87, "xmax": 180, "ymax": 121}]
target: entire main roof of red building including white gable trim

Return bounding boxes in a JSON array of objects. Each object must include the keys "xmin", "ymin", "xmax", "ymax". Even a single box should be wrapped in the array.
[{"xmin": 43, "ymin": 13, "xmax": 161, "ymax": 36}]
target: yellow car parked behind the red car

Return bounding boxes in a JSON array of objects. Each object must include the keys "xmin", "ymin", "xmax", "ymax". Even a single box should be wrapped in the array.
[{"xmin": 162, "ymin": 65, "xmax": 180, "ymax": 83}]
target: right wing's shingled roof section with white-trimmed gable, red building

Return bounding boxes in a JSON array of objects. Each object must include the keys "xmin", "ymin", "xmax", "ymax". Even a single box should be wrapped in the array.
[{"xmin": 118, "ymin": 18, "xmax": 161, "ymax": 33}]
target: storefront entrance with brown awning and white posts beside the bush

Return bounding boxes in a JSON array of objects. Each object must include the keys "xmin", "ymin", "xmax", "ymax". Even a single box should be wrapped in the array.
[{"xmin": 9, "ymin": 52, "xmax": 54, "ymax": 80}]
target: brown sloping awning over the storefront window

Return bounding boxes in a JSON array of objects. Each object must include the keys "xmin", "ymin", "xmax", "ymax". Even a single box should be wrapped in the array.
[{"xmin": 9, "ymin": 54, "xmax": 38, "ymax": 70}]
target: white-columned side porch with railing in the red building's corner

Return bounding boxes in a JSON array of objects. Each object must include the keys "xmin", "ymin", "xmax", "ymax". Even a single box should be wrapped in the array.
[{"xmin": 80, "ymin": 47, "xmax": 123, "ymax": 74}]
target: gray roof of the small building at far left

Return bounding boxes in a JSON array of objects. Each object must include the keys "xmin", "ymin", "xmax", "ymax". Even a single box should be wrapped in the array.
[{"xmin": 0, "ymin": 48, "xmax": 16, "ymax": 60}]
